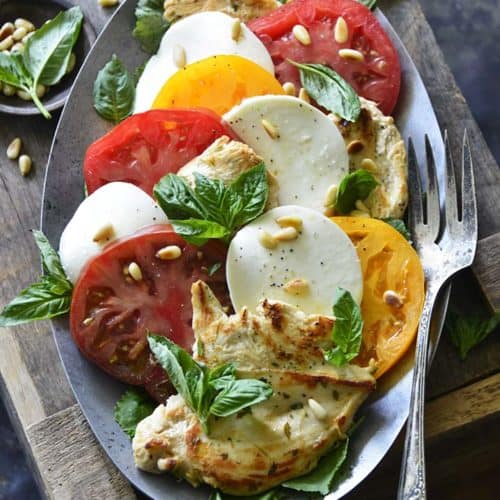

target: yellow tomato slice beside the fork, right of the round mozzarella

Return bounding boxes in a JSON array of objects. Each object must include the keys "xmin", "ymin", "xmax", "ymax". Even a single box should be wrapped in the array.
[{"xmin": 332, "ymin": 217, "xmax": 425, "ymax": 378}]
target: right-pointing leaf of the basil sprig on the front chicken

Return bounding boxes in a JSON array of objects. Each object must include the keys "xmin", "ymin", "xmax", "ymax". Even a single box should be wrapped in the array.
[{"xmin": 210, "ymin": 379, "xmax": 273, "ymax": 417}]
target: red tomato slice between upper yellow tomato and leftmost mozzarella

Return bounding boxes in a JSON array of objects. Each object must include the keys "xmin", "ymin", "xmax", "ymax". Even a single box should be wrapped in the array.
[{"xmin": 83, "ymin": 108, "xmax": 236, "ymax": 195}]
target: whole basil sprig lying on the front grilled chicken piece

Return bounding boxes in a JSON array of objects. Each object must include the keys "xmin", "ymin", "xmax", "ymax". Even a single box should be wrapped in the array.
[{"xmin": 148, "ymin": 334, "xmax": 273, "ymax": 435}]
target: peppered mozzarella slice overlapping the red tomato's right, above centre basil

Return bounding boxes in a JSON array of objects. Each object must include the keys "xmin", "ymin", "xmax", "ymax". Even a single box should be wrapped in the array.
[{"xmin": 224, "ymin": 96, "xmax": 349, "ymax": 211}]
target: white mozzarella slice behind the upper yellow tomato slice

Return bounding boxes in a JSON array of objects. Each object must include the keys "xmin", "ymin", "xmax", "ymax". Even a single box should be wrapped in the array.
[{"xmin": 134, "ymin": 12, "xmax": 274, "ymax": 113}]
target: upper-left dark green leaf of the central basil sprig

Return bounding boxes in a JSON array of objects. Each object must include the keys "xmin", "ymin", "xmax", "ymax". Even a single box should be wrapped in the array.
[{"xmin": 153, "ymin": 174, "xmax": 207, "ymax": 220}]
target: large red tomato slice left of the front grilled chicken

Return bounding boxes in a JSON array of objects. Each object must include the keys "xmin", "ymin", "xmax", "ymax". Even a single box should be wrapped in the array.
[{"xmin": 70, "ymin": 225, "xmax": 230, "ymax": 400}]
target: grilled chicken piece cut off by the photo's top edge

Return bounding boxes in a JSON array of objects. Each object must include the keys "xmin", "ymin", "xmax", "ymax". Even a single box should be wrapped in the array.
[{"xmin": 163, "ymin": 0, "xmax": 281, "ymax": 23}]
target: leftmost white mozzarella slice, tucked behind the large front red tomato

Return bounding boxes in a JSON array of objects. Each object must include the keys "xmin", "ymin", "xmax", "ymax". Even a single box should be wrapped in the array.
[{"xmin": 59, "ymin": 182, "xmax": 168, "ymax": 283}]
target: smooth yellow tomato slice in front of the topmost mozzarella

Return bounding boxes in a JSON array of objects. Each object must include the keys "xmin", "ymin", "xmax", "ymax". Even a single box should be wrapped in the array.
[{"xmin": 153, "ymin": 56, "xmax": 284, "ymax": 115}]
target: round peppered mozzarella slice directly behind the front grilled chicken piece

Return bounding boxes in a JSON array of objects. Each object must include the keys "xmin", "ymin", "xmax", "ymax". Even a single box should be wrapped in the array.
[{"xmin": 226, "ymin": 205, "xmax": 363, "ymax": 316}]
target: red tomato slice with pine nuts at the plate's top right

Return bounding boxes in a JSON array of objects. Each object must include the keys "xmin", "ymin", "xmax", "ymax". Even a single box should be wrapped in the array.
[{"xmin": 249, "ymin": 0, "xmax": 401, "ymax": 114}]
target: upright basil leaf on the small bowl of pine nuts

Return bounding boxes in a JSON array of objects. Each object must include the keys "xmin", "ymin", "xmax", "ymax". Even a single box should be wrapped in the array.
[{"xmin": 23, "ymin": 7, "xmax": 83, "ymax": 88}]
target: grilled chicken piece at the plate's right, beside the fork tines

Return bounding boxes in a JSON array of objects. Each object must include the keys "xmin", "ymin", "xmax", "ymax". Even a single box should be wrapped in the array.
[{"xmin": 331, "ymin": 97, "xmax": 408, "ymax": 219}]
